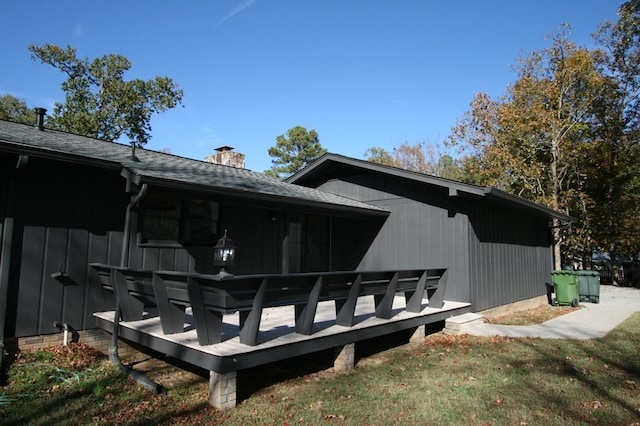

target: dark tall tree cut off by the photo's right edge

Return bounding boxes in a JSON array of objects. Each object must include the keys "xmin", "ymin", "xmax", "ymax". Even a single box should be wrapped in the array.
[{"xmin": 590, "ymin": 0, "xmax": 640, "ymax": 259}]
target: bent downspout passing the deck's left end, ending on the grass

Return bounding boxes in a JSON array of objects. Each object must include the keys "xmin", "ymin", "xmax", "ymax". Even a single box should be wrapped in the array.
[{"xmin": 109, "ymin": 183, "xmax": 165, "ymax": 395}]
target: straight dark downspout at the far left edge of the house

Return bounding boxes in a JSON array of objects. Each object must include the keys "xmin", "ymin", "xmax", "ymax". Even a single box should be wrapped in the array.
[{"xmin": 0, "ymin": 155, "xmax": 29, "ymax": 371}]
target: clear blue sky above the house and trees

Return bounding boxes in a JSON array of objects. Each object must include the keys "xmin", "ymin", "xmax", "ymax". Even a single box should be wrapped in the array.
[{"xmin": 0, "ymin": 0, "xmax": 622, "ymax": 171}]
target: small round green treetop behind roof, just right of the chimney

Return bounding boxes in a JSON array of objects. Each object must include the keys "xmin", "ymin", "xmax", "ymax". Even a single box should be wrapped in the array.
[{"xmin": 265, "ymin": 126, "xmax": 327, "ymax": 179}]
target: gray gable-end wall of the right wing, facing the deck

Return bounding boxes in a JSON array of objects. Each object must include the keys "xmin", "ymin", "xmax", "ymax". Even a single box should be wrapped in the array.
[{"xmin": 318, "ymin": 175, "xmax": 471, "ymax": 302}]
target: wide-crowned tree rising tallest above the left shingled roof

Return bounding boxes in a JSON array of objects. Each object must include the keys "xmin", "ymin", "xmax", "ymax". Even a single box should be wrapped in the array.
[{"xmin": 29, "ymin": 44, "xmax": 183, "ymax": 146}]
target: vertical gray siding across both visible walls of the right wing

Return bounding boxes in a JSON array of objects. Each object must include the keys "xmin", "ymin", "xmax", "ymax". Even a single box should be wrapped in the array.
[{"xmin": 319, "ymin": 173, "xmax": 552, "ymax": 310}]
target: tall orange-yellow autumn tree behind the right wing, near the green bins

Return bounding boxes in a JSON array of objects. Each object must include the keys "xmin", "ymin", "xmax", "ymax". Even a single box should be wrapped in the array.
[{"xmin": 452, "ymin": 26, "xmax": 606, "ymax": 268}]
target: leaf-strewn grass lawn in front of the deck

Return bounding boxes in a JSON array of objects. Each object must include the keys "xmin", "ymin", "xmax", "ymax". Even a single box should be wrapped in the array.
[{"xmin": 0, "ymin": 313, "xmax": 640, "ymax": 425}]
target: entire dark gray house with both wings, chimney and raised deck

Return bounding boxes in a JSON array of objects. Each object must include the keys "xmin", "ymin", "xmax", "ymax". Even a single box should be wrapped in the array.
[{"xmin": 0, "ymin": 121, "xmax": 571, "ymax": 408}]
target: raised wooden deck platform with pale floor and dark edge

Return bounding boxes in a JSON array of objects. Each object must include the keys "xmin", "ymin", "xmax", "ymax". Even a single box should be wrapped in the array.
[{"xmin": 94, "ymin": 295, "xmax": 470, "ymax": 374}]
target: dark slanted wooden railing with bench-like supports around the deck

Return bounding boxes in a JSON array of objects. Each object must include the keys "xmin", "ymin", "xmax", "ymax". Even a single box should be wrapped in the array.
[{"xmin": 91, "ymin": 263, "xmax": 447, "ymax": 345}]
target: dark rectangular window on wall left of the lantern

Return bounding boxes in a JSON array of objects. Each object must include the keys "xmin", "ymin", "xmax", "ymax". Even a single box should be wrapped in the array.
[{"xmin": 140, "ymin": 195, "xmax": 218, "ymax": 245}]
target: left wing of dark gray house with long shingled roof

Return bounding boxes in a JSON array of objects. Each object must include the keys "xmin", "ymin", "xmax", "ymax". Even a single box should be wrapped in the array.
[{"xmin": 0, "ymin": 121, "xmax": 389, "ymax": 348}]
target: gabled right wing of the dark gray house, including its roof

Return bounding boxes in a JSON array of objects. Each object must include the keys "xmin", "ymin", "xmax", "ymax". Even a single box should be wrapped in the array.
[{"xmin": 288, "ymin": 154, "xmax": 572, "ymax": 312}]
